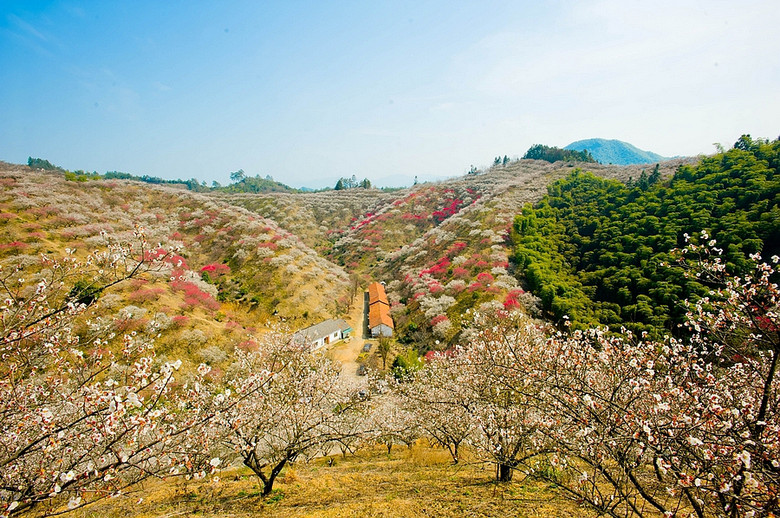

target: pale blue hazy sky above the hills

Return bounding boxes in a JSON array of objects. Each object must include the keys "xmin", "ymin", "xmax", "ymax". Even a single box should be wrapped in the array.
[{"xmin": 0, "ymin": 0, "xmax": 780, "ymax": 186}]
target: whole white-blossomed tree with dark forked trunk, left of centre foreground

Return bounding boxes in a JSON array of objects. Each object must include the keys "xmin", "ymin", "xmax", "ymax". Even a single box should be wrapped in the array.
[{"xmin": 219, "ymin": 332, "xmax": 367, "ymax": 495}]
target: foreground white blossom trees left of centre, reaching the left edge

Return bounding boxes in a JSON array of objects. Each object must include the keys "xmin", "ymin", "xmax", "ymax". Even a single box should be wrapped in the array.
[{"xmin": 0, "ymin": 235, "xmax": 367, "ymax": 516}]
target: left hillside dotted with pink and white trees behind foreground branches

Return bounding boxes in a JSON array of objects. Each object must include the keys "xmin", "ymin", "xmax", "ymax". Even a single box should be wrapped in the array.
[{"xmin": 0, "ymin": 164, "xmax": 348, "ymax": 370}]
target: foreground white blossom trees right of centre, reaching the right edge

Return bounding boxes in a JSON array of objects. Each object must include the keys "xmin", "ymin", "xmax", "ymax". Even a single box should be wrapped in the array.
[{"xmin": 398, "ymin": 238, "xmax": 780, "ymax": 517}]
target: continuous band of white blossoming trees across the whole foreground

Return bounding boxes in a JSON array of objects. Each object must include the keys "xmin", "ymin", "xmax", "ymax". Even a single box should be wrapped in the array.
[{"xmin": 0, "ymin": 233, "xmax": 780, "ymax": 517}]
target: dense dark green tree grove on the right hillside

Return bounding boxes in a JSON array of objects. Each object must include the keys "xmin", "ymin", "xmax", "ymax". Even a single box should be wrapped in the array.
[{"xmin": 513, "ymin": 136, "xmax": 780, "ymax": 334}]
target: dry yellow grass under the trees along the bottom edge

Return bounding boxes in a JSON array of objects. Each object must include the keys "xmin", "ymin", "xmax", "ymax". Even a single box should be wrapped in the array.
[{"xmin": 71, "ymin": 445, "xmax": 595, "ymax": 518}]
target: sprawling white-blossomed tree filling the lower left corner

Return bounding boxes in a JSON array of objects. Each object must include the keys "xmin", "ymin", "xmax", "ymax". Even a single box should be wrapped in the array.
[{"xmin": 0, "ymin": 232, "xmax": 218, "ymax": 516}]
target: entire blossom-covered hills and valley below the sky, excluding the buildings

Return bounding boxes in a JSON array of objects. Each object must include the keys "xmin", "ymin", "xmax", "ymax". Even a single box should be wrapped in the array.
[{"xmin": 0, "ymin": 137, "xmax": 780, "ymax": 516}]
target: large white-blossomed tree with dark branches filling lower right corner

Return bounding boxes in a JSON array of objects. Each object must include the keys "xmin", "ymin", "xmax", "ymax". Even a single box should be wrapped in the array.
[{"xmin": 524, "ymin": 240, "xmax": 780, "ymax": 517}]
